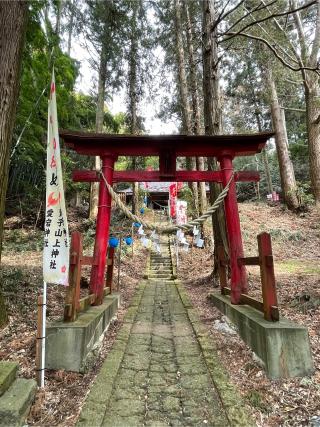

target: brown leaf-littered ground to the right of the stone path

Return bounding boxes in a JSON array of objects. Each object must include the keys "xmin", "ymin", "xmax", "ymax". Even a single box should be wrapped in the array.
[{"xmin": 179, "ymin": 203, "xmax": 320, "ymax": 427}]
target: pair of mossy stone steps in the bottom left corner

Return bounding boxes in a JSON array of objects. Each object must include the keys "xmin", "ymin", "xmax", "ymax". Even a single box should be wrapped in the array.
[{"xmin": 0, "ymin": 361, "xmax": 37, "ymax": 427}]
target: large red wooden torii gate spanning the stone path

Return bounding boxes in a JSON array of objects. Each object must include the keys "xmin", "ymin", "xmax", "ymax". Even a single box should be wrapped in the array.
[{"xmin": 60, "ymin": 131, "xmax": 274, "ymax": 304}]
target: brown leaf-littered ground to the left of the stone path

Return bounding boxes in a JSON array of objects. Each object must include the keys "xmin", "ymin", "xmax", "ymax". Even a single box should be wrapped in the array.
[{"xmin": 0, "ymin": 206, "xmax": 147, "ymax": 426}]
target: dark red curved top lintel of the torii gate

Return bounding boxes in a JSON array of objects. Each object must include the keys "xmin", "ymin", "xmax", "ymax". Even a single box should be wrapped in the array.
[{"xmin": 60, "ymin": 130, "xmax": 274, "ymax": 157}]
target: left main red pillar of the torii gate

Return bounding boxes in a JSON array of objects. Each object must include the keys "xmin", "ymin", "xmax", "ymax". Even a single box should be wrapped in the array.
[{"xmin": 90, "ymin": 156, "xmax": 116, "ymax": 305}]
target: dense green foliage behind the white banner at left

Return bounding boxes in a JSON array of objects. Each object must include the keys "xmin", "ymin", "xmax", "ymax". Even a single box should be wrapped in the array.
[{"xmin": 7, "ymin": 2, "xmax": 125, "ymax": 214}]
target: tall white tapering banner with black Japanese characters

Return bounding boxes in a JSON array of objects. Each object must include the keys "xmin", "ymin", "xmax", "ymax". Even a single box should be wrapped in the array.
[{"xmin": 43, "ymin": 71, "xmax": 69, "ymax": 286}]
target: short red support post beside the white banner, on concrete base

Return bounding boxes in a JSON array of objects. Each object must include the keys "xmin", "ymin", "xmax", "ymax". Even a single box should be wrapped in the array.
[{"xmin": 64, "ymin": 231, "xmax": 82, "ymax": 322}]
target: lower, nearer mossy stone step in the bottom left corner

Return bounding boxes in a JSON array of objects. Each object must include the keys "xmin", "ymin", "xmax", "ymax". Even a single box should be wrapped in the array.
[{"xmin": 0, "ymin": 378, "xmax": 37, "ymax": 427}]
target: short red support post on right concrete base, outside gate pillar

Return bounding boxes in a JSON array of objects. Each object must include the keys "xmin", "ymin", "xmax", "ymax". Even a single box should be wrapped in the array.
[{"xmin": 257, "ymin": 233, "xmax": 279, "ymax": 320}]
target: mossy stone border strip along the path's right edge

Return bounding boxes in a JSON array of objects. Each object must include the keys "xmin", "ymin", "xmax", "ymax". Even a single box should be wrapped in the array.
[{"xmin": 174, "ymin": 280, "xmax": 256, "ymax": 427}]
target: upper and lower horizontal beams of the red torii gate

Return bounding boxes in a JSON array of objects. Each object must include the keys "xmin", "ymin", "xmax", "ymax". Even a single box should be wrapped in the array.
[{"xmin": 60, "ymin": 131, "xmax": 273, "ymax": 182}]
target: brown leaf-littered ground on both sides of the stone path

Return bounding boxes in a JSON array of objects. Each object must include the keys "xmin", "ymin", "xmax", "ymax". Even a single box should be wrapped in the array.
[{"xmin": 0, "ymin": 203, "xmax": 320, "ymax": 426}]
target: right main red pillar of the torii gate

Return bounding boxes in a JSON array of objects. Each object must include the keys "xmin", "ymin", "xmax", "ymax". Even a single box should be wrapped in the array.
[{"xmin": 218, "ymin": 154, "xmax": 248, "ymax": 304}]
